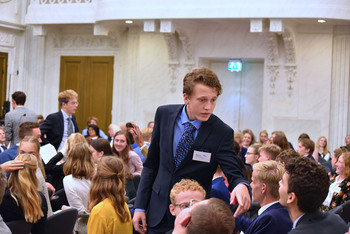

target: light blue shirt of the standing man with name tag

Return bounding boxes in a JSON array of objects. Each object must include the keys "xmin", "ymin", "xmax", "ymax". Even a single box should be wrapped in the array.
[{"xmin": 173, "ymin": 105, "xmax": 202, "ymax": 157}]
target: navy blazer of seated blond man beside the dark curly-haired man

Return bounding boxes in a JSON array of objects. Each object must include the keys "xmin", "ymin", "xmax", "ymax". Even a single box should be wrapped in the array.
[{"xmin": 236, "ymin": 203, "xmax": 293, "ymax": 234}]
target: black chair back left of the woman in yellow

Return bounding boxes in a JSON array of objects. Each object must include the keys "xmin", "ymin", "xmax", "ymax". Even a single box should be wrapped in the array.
[{"xmin": 46, "ymin": 208, "xmax": 78, "ymax": 234}]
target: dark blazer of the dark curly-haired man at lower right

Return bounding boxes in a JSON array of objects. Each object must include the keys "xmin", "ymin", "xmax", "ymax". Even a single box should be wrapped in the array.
[{"xmin": 289, "ymin": 210, "xmax": 348, "ymax": 234}]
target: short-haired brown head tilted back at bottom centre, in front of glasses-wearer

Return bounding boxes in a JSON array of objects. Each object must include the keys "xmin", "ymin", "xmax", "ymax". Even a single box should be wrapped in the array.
[{"xmin": 173, "ymin": 198, "xmax": 235, "ymax": 234}]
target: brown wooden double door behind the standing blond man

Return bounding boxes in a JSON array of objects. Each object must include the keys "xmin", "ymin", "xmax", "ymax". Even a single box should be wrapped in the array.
[{"xmin": 60, "ymin": 56, "xmax": 114, "ymax": 134}]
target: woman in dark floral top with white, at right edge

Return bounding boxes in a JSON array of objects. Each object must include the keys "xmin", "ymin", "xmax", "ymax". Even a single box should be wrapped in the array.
[{"xmin": 321, "ymin": 152, "xmax": 350, "ymax": 211}]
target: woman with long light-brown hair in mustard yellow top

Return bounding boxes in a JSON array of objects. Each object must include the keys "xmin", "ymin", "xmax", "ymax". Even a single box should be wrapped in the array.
[{"xmin": 87, "ymin": 156, "xmax": 132, "ymax": 234}]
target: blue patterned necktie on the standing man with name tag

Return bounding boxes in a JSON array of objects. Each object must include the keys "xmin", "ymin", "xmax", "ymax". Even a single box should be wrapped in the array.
[{"xmin": 175, "ymin": 122, "xmax": 196, "ymax": 168}]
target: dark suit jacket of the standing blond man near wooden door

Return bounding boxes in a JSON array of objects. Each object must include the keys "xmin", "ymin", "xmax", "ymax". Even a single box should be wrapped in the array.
[{"xmin": 40, "ymin": 111, "xmax": 79, "ymax": 150}]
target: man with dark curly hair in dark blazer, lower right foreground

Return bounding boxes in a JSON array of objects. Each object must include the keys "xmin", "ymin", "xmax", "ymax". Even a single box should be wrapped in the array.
[{"xmin": 279, "ymin": 157, "xmax": 348, "ymax": 234}]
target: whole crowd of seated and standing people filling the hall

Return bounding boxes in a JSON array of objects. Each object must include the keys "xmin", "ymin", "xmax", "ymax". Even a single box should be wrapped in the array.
[{"xmin": 0, "ymin": 68, "xmax": 350, "ymax": 234}]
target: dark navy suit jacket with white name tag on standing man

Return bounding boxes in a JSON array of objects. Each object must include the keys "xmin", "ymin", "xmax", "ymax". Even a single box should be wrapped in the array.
[{"xmin": 135, "ymin": 105, "xmax": 248, "ymax": 231}]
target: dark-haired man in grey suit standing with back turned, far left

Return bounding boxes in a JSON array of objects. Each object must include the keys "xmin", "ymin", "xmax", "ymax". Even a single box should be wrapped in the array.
[{"xmin": 5, "ymin": 91, "xmax": 37, "ymax": 146}]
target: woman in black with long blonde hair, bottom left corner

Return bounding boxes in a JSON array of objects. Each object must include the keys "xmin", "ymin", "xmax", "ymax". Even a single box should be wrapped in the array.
[{"xmin": 0, "ymin": 154, "xmax": 47, "ymax": 234}]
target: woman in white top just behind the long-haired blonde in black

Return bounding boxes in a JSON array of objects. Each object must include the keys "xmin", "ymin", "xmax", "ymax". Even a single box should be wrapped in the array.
[{"xmin": 18, "ymin": 136, "xmax": 55, "ymax": 216}]
